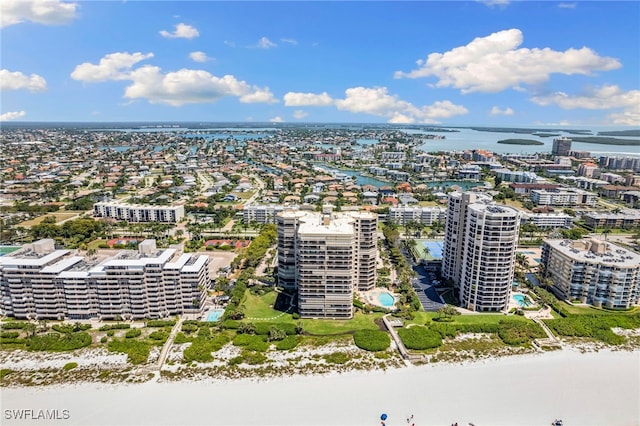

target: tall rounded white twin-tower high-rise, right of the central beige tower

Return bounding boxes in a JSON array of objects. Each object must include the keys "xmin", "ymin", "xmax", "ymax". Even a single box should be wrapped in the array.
[{"xmin": 442, "ymin": 192, "xmax": 520, "ymax": 312}]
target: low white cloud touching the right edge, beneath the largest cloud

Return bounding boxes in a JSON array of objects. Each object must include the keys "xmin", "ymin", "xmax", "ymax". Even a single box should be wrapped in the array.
[{"xmin": 531, "ymin": 85, "xmax": 640, "ymax": 126}]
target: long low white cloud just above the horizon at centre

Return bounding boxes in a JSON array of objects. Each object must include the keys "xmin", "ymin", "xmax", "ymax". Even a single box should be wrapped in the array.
[{"xmin": 284, "ymin": 87, "xmax": 468, "ymax": 123}]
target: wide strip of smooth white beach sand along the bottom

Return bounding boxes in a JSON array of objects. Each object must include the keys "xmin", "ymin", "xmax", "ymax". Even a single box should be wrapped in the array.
[{"xmin": 0, "ymin": 349, "xmax": 640, "ymax": 426}]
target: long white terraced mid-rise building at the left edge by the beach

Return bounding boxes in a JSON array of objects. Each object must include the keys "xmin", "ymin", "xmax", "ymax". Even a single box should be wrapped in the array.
[{"xmin": 0, "ymin": 240, "xmax": 210, "ymax": 319}]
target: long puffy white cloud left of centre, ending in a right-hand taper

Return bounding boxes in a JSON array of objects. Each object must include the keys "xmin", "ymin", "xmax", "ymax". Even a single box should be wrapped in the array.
[{"xmin": 124, "ymin": 65, "xmax": 277, "ymax": 106}]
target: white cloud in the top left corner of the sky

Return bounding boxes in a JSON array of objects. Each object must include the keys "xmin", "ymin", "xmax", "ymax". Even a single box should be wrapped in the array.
[{"xmin": 0, "ymin": 0, "xmax": 78, "ymax": 27}]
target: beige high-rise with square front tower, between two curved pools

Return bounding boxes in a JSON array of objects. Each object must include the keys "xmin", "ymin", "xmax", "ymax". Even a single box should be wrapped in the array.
[{"xmin": 276, "ymin": 207, "xmax": 378, "ymax": 318}]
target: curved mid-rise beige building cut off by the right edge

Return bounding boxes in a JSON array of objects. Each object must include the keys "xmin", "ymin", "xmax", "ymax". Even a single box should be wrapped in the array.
[{"xmin": 541, "ymin": 239, "xmax": 640, "ymax": 308}]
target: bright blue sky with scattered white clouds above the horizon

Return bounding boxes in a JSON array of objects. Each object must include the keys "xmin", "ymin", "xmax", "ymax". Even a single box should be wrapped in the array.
[{"xmin": 0, "ymin": 0, "xmax": 640, "ymax": 127}]
